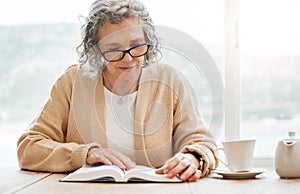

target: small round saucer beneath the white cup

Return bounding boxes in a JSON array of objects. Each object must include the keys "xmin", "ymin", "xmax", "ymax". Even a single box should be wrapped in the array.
[{"xmin": 213, "ymin": 168, "xmax": 266, "ymax": 179}]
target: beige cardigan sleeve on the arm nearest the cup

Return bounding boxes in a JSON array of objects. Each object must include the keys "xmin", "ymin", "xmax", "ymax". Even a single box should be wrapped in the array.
[{"xmin": 173, "ymin": 71, "xmax": 218, "ymax": 176}]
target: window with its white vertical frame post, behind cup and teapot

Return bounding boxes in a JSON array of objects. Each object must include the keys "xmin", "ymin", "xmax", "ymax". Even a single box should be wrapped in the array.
[{"xmin": 225, "ymin": 0, "xmax": 300, "ymax": 162}]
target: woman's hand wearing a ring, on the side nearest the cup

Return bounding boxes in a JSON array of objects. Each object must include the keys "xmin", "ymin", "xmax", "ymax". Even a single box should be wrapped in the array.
[{"xmin": 155, "ymin": 153, "xmax": 202, "ymax": 182}]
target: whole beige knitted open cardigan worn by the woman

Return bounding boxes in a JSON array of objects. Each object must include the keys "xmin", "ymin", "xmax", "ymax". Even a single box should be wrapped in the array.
[{"xmin": 18, "ymin": 64, "xmax": 217, "ymax": 176}]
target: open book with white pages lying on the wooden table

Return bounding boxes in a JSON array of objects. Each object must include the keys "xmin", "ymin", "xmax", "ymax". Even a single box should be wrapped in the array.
[{"xmin": 60, "ymin": 165, "xmax": 182, "ymax": 182}]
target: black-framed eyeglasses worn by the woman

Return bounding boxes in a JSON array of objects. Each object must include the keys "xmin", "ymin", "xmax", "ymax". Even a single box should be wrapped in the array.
[{"xmin": 98, "ymin": 43, "xmax": 150, "ymax": 62}]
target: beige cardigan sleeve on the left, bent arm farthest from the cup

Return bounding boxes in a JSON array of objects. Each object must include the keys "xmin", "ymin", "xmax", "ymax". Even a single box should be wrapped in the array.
[{"xmin": 17, "ymin": 66, "xmax": 99, "ymax": 172}]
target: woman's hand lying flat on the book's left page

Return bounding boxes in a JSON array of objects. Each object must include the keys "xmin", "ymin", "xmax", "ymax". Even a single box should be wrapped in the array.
[{"xmin": 86, "ymin": 148, "xmax": 135, "ymax": 170}]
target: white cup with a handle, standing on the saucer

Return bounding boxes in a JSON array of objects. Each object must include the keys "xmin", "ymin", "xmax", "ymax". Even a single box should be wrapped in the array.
[{"xmin": 216, "ymin": 139, "xmax": 256, "ymax": 172}]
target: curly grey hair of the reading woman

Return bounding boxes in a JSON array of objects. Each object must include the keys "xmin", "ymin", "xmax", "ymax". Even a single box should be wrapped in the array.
[{"xmin": 76, "ymin": 0, "xmax": 161, "ymax": 77}]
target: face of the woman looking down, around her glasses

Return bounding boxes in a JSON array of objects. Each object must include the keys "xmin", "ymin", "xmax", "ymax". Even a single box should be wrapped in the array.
[{"xmin": 97, "ymin": 17, "xmax": 146, "ymax": 81}]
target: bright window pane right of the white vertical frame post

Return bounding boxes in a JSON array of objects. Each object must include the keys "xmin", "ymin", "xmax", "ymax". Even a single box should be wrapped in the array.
[{"xmin": 239, "ymin": 0, "xmax": 300, "ymax": 157}]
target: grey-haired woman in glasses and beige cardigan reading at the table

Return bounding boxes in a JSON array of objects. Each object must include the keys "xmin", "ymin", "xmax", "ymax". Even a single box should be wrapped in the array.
[{"xmin": 18, "ymin": 0, "xmax": 217, "ymax": 181}]
